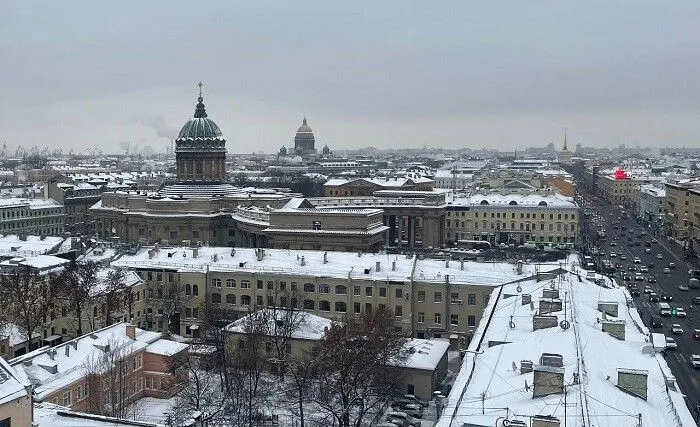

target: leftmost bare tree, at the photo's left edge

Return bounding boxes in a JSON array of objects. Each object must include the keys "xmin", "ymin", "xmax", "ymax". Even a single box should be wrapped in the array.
[{"xmin": 0, "ymin": 268, "xmax": 54, "ymax": 352}]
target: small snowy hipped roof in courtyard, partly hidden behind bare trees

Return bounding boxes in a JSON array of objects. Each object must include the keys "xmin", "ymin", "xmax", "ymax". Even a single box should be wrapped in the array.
[{"xmin": 224, "ymin": 308, "xmax": 333, "ymax": 340}]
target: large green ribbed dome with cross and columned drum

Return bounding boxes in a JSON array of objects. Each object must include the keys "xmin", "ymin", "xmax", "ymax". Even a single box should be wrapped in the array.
[{"xmin": 175, "ymin": 82, "xmax": 226, "ymax": 182}]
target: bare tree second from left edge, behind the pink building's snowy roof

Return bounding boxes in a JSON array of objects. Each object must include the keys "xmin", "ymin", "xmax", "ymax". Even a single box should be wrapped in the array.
[{"xmin": 54, "ymin": 261, "xmax": 99, "ymax": 336}]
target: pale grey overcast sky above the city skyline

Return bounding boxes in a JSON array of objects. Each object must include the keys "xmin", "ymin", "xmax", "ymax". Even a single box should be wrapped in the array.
[{"xmin": 0, "ymin": 0, "xmax": 700, "ymax": 153}]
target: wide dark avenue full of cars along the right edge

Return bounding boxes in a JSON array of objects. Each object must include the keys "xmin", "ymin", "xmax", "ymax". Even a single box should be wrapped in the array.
[{"xmin": 584, "ymin": 197, "xmax": 700, "ymax": 418}]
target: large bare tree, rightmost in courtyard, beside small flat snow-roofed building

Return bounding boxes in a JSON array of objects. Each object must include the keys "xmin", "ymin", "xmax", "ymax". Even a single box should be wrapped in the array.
[{"xmin": 313, "ymin": 309, "xmax": 406, "ymax": 427}]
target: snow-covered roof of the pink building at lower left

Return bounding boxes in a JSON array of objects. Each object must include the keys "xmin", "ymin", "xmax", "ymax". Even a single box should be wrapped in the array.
[{"xmin": 10, "ymin": 322, "xmax": 183, "ymax": 399}]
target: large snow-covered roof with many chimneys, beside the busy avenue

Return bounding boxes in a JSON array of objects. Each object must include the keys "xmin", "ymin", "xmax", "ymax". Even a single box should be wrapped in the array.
[{"xmin": 437, "ymin": 257, "xmax": 694, "ymax": 427}]
